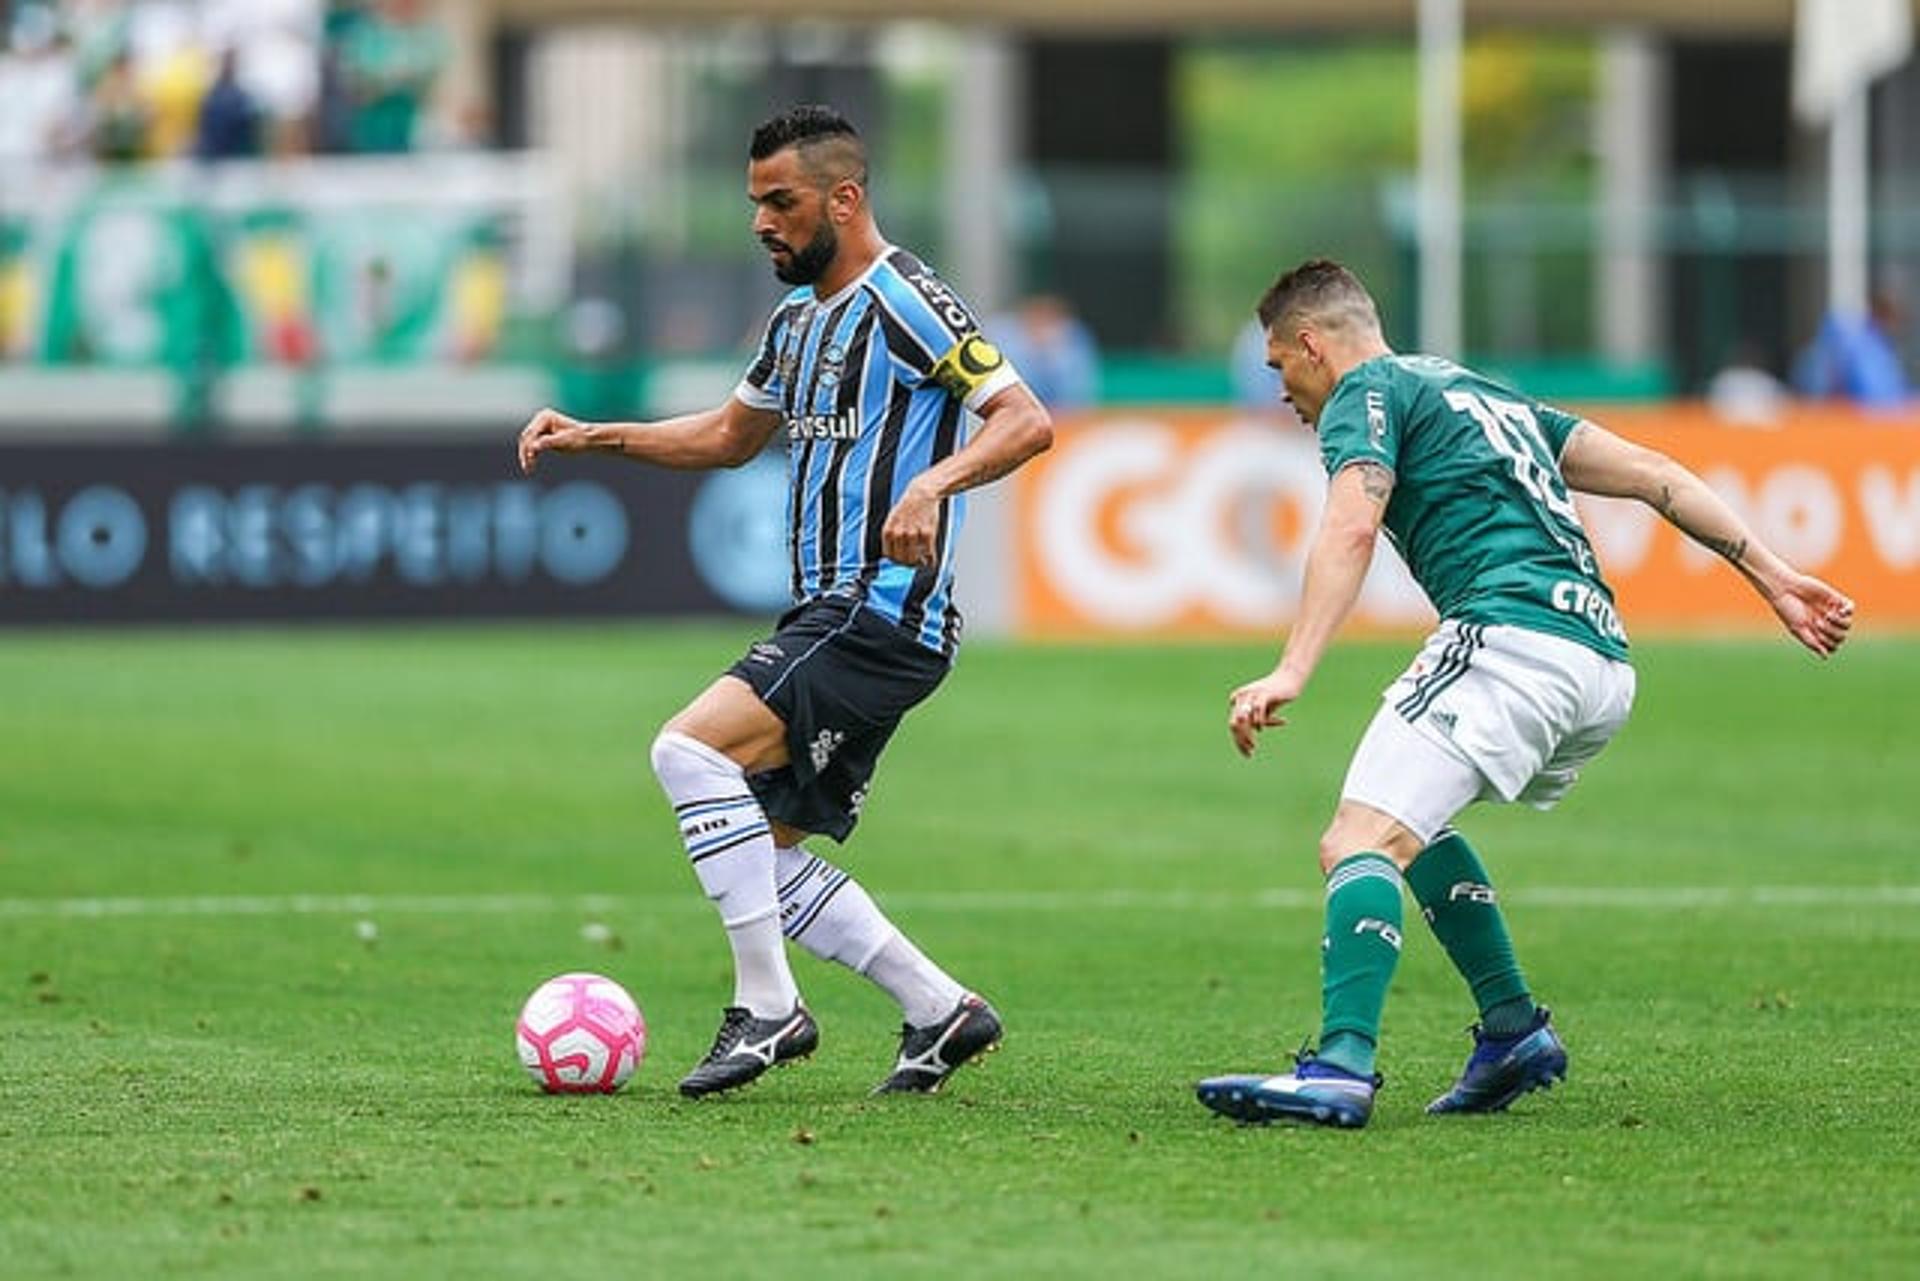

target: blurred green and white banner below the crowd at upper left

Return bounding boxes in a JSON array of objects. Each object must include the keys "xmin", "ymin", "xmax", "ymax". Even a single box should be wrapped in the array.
[{"xmin": 0, "ymin": 175, "xmax": 509, "ymax": 375}]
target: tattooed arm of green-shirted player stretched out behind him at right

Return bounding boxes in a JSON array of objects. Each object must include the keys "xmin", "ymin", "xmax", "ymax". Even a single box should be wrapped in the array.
[{"xmin": 1561, "ymin": 423, "xmax": 1853, "ymax": 659}]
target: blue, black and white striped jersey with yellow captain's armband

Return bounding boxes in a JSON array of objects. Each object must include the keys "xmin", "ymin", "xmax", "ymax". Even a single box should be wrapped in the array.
[{"xmin": 733, "ymin": 248, "xmax": 1020, "ymax": 655}]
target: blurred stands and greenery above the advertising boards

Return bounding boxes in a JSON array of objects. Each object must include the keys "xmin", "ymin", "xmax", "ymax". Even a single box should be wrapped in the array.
[{"xmin": 0, "ymin": 0, "xmax": 1920, "ymax": 432}]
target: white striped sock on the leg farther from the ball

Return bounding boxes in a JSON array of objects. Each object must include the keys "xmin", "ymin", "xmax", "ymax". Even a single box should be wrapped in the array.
[{"xmin": 774, "ymin": 847, "xmax": 966, "ymax": 1027}]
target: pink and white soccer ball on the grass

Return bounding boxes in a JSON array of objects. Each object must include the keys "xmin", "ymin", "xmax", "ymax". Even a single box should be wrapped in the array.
[{"xmin": 515, "ymin": 974, "xmax": 647, "ymax": 1095}]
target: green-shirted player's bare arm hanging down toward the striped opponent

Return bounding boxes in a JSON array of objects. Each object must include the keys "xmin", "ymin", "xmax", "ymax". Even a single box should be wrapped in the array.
[{"xmin": 1227, "ymin": 463, "xmax": 1394, "ymax": 757}]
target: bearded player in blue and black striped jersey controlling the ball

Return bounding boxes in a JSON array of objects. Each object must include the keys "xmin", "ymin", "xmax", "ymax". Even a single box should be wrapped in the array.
[{"xmin": 520, "ymin": 108, "xmax": 1052, "ymax": 1097}]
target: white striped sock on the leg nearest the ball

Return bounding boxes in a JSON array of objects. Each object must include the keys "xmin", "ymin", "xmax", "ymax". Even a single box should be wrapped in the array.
[{"xmin": 653, "ymin": 730, "xmax": 801, "ymax": 1018}]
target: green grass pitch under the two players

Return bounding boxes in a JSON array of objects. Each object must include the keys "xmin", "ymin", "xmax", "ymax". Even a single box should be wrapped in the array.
[{"xmin": 0, "ymin": 626, "xmax": 1920, "ymax": 1279}]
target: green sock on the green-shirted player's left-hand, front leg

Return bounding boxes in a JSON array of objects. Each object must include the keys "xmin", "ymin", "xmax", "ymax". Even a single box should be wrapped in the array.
[{"xmin": 1319, "ymin": 851, "xmax": 1402, "ymax": 1076}]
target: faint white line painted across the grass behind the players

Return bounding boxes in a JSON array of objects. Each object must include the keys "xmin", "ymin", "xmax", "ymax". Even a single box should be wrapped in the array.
[{"xmin": 0, "ymin": 885, "xmax": 1920, "ymax": 920}]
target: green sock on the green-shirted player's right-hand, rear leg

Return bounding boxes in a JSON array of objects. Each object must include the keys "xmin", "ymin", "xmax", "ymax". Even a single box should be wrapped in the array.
[{"xmin": 1407, "ymin": 832, "xmax": 1534, "ymax": 1037}]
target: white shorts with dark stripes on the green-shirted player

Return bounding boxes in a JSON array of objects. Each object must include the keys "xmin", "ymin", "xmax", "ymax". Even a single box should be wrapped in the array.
[{"xmin": 1340, "ymin": 620, "xmax": 1634, "ymax": 841}]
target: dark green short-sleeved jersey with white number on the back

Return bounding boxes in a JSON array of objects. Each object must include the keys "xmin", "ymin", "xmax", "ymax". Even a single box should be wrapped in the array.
[{"xmin": 1319, "ymin": 355, "xmax": 1626, "ymax": 659}]
